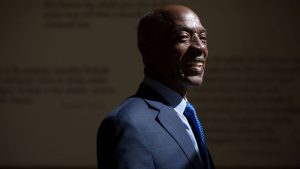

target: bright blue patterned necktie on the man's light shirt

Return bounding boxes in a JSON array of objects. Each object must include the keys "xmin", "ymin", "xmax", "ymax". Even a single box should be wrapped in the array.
[{"xmin": 183, "ymin": 102, "xmax": 211, "ymax": 169}]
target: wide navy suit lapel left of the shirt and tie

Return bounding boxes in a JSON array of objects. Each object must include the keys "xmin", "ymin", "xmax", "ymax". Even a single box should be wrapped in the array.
[{"xmin": 136, "ymin": 84, "xmax": 202, "ymax": 169}]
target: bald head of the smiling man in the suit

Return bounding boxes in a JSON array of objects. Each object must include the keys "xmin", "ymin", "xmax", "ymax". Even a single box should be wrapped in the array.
[{"xmin": 138, "ymin": 5, "xmax": 208, "ymax": 95}]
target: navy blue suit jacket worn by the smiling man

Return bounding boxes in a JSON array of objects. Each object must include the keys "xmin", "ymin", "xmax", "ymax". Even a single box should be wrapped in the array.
[{"xmin": 97, "ymin": 84, "xmax": 214, "ymax": 169}]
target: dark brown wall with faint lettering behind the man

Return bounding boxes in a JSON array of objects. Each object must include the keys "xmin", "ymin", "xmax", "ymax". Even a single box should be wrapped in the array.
[{"xmin": 0, "ymin": 0, "xmax": 300, "ymax": 169}]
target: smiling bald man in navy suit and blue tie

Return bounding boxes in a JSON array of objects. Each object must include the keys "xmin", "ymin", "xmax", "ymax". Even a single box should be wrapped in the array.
[{"xmin": 97, "ymin": 5, "xmax": 214, "ymax": 169}]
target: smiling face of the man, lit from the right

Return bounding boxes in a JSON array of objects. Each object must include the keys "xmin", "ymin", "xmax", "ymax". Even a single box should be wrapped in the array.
[{"xmin": 157, "ymin": 10, "xmax": 208, "ymax": 88}]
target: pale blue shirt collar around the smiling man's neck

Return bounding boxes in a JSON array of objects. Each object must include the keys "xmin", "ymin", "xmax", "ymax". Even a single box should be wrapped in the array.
[{"xmin": 143, "ymin": 76, "xmax": 187, "ymax": 114}]
